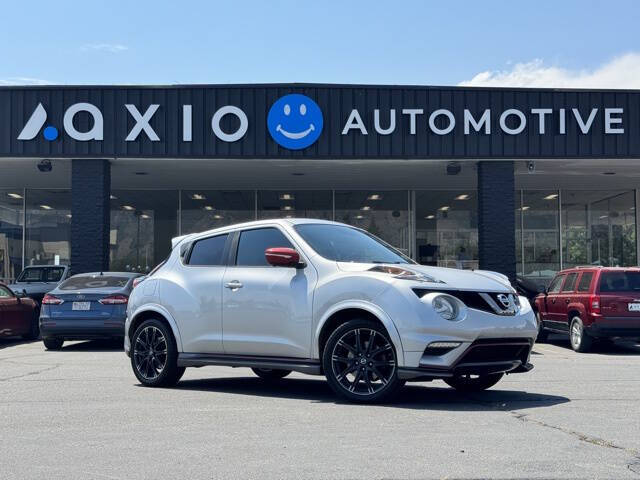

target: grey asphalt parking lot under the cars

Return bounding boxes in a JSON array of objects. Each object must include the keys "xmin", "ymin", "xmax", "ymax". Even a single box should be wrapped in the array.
[{"xmin": 0, "ymin": 340, "xmax": 640, "ymax": 479}]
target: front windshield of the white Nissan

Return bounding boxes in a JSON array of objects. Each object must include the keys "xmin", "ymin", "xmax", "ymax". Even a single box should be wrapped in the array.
[{"xmin": 294, "ymin": 223, "xmax": 415, "ymax": 263}]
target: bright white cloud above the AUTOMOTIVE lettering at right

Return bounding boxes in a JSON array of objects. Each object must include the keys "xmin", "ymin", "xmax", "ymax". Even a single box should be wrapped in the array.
[{"xmin": 458, "ymin": 53, "xmax": 640, "ymax": 88}]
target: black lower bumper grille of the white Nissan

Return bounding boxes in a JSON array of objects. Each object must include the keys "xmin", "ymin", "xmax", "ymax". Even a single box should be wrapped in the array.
[{"xmin": 457, "ymin": 338, "xmax": 531, "ymax": 366}]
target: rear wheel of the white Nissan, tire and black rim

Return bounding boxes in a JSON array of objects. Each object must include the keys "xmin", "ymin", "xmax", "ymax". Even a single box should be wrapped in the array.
[{"xmin": 131, "ymin": 319, "xmax": 185, "ymax": 387}]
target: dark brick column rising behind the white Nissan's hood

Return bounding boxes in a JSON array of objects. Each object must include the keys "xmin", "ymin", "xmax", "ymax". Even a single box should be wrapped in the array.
[{"xmin": 478, "ymin": 161, "xmax": 516, "ymax": 281}]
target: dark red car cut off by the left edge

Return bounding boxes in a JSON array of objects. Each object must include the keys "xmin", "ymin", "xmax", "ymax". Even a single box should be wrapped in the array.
[{"xmin": 0, "ymin": 283, "xmax": 40, "ymax": 340}]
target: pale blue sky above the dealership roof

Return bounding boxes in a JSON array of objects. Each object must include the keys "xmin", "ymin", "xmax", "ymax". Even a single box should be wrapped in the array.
[{"xmin": 0, "ymin": 0, "xmax": 640, "ymax": 88}]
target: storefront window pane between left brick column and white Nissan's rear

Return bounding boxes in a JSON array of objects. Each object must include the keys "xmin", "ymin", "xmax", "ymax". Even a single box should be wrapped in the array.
[{"xmin": 109, "ymin": 190, "xmax": 178, "ymax": 273}]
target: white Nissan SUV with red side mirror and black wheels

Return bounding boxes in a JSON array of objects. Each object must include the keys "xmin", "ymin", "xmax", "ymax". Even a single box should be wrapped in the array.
[{"xmin": 125, "ymin": 219, "xmax": 537, "ymax": 402}]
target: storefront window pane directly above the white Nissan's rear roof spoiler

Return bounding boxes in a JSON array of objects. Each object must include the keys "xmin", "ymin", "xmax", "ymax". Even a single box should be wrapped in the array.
[{"xmin": 181, "ymin": 190, "xmax": 255, "ymax": 235}]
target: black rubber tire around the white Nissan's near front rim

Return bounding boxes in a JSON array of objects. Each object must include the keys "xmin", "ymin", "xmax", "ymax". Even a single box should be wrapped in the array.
[{"xmin": 322, "ymin": 319, "xmax": 404, "ymax": 403}]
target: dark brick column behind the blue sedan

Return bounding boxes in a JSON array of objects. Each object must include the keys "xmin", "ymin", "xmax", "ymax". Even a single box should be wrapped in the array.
[{"xmin": 71, "ymin": 159, "xmax": 111, "ymax": 273}]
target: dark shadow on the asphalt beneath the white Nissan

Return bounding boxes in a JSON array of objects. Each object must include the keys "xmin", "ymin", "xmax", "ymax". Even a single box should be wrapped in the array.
[{"xmin": 173, "ymin": 377, "xmax": 570, "ymax": 411}]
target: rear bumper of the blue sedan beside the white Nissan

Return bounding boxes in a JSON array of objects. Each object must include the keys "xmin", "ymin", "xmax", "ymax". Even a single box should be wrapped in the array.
[{"xmin": 40, "ymin": 318, "xmax": 124, "ymax": 340}]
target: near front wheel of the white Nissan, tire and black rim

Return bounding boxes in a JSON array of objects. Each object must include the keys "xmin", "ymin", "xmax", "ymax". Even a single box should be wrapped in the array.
[{"xmin": 322, "ymin": 319, "xmax": 404, "ymax": 403}]
